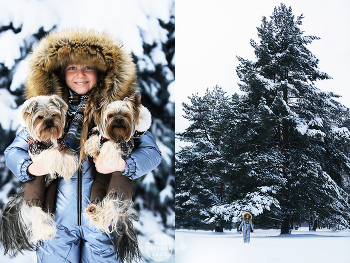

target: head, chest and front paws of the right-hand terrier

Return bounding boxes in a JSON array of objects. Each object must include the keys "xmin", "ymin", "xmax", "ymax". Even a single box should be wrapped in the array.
[{"xmin": 84, "ymin": 92, "xmax": 152, "ymax": 171}]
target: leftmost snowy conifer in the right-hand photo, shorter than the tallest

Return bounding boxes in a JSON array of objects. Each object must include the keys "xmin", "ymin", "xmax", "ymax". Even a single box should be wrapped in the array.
[{"xmin": 176, "ymin": 86, "xmax": 231, "ymax": 231}]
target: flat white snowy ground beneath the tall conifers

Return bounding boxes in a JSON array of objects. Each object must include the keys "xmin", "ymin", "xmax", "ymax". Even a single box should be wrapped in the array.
[{"xmin": 175, "ymin": 227, "xmax": 350, "ymax": 263}]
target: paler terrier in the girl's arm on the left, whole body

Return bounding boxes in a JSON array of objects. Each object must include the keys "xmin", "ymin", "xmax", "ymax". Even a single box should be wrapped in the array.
[{"xmin": 0, "ymin": 95, "xmax": 78, "ymax": 249}]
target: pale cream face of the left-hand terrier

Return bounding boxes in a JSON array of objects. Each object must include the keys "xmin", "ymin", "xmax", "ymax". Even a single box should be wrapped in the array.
[{"xmin": 22, "ymin": 95, "xmax": 68, "ymax": 141}]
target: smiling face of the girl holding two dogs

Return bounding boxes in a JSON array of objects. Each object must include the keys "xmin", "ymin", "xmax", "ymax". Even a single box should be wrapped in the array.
[{"xmin": 65, "ymin": 64, "xmax": 97, "ymax": 95}]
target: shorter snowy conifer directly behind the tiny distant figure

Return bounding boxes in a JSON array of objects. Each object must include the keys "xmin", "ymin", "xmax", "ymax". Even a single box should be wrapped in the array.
[{"xmin": 204, "ymin": 94, "xmax": 283, "ymax": 232}]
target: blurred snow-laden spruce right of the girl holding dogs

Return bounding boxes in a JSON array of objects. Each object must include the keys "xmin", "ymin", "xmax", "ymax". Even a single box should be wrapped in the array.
[{"xmin": 134, "ymin": 8, "xmax": 175, "ymax": 235}]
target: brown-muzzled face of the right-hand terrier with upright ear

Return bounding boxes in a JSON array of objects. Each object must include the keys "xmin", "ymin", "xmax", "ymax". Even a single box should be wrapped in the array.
[{"xmin": 96, "ymin": 92, "xmax": 141, "ymax": 141}]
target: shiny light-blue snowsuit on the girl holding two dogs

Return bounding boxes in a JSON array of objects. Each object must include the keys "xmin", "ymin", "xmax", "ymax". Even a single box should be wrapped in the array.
[{"xmin": 5, "ymin": 130, "xmax": 161, "ymax": 263}]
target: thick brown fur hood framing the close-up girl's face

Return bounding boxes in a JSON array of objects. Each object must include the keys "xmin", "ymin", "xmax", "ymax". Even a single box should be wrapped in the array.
[{"xmin": 25, "ymin": 29, "xmax": 136, "ymax": 102}]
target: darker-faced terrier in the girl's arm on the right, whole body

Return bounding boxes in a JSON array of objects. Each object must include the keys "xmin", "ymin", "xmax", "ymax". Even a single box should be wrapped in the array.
[{"xmin": 84, "ymin": 92, "xmax": 151, "ymax": 250}]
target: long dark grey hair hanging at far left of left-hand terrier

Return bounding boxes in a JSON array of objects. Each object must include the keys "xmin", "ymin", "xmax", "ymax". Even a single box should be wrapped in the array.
[{"xmin": 0, "ymin": 189, "xmax": 38, "ymax": 256}]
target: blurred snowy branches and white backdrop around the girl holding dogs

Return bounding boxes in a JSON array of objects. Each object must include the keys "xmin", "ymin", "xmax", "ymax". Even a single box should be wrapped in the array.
[{"xmin": 0, "ymin": 0, "xmax": 175, "ymax": 263}]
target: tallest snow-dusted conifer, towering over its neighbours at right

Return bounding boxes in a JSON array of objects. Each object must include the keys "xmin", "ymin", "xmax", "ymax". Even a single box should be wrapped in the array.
[{"xmin": 236, "ymin": 4, "xmax": 350, "ymax": 234}]
